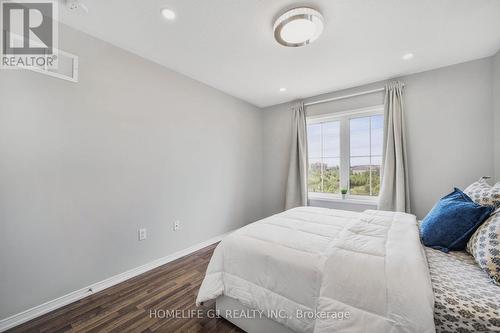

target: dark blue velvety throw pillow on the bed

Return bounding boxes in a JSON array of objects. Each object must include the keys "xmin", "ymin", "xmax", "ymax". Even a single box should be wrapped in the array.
[{"xmin": 420, "ymin": 188, "xmax": 495, "ymax": 252}]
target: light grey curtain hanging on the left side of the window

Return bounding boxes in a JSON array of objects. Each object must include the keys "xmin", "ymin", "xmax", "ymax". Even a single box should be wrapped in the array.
[{"xmin": 285, "ymin": 102, "xmax": 307, "ymax": 209}]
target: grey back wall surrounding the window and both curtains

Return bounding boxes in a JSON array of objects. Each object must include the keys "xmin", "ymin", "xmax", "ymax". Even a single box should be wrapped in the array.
[{"xmin": 264, "ymin": 58, "xmax": 494, "ymax": 218}]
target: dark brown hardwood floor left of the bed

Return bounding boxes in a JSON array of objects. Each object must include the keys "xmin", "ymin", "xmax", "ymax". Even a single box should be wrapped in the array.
[{"xmin": 8, "ymin": 245, "xmax": 243, "ymax": 333}]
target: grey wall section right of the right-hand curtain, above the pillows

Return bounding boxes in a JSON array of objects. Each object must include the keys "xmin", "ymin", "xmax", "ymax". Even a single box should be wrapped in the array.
[{"xmin": 402, "ymin": 58, "xmax": 493, "ymax": 217}]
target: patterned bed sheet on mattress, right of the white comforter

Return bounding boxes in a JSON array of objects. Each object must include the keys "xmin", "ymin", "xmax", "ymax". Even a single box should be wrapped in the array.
[{"xmin": 425, "ymin": 248, "xmax": 500, "ymax": 333}]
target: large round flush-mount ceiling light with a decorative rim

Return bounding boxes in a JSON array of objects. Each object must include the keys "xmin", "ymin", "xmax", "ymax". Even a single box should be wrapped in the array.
[{"xmin": 273, "ymin": 7, "xmax": 323, "ymax": 47}]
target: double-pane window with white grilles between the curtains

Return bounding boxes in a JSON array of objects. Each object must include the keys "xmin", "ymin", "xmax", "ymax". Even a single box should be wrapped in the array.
[{"xmin": 307, "ymin": 107, "xmax": 384, "ymax": 199}]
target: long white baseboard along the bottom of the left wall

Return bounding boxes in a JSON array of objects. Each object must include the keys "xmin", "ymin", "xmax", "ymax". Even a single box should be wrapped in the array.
[{"xmin": 0, "ymin": 233, "xmax": 229, "ymax": 332}]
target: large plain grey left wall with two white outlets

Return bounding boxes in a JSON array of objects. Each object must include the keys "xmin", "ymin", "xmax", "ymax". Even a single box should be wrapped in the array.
[{"xmin": 0, "ymin": 27, "xmax": 263, "ymax": 318}]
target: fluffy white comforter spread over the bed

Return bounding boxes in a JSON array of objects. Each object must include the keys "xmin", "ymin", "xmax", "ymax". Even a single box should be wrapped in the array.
[{"xmin": 196, "ymin": 207, "xmax": 434, "ymax": 333}]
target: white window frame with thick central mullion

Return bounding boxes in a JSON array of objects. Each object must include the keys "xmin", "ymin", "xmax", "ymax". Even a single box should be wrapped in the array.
[{"xmin": 306, "ymin": 105, "xmax": 385, "ymax": 204}]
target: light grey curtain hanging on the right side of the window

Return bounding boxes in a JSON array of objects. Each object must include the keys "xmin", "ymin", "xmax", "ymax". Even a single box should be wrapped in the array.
[{"xmin": 379, "ymin": 81, "xmax": 410, "ymax": 213}]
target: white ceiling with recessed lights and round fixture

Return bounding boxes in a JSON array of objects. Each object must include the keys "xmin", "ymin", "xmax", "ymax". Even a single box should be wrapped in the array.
[{"xmin": 61, "ymin": 0, "xmax": 500, "ymax": 107}]
